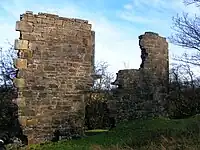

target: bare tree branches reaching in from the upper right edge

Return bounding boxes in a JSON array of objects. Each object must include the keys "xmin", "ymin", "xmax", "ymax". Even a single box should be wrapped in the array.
[{"xmin": 169, "ymin": 0, "xmax": 200, "ymax": 66}]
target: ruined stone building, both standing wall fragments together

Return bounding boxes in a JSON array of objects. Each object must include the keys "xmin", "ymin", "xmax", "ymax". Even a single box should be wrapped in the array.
[{"xmin": 14, "ymin": 12, "xmax": 168, "ymax": 143}]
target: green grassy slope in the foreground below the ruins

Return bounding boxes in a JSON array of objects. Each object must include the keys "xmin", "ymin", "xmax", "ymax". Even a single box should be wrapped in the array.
[{"xmin": 27, "ymin": 116, "xmax": 200, "ymax": 150}]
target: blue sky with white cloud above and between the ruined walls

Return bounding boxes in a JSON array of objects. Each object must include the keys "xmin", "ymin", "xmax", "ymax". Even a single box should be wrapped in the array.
[{"xmin": 0, "ymin": 0, "xmax": 198, "ymax": 73}]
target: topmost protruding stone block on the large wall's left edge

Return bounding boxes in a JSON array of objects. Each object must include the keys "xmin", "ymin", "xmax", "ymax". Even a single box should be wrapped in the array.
[{"xmin": 15, "ymin": 21, "xmax": 33, "ymax": 32}]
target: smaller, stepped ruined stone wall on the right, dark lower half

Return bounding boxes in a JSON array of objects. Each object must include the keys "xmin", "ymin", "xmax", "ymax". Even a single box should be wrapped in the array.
[{"xmin": 113, "ymin": 32, "xmax": 169, "ymax": 121}]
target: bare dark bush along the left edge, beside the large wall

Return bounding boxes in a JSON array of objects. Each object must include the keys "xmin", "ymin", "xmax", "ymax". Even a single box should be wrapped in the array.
[{"xmin": 0, "ymin": 44, "xmax": 28, "ymax": 149}]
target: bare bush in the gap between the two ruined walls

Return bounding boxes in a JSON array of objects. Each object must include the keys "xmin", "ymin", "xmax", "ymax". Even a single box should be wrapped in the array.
[{"xmin": 85, "ymin": 61, "xmax": 114, "ymax": 129}]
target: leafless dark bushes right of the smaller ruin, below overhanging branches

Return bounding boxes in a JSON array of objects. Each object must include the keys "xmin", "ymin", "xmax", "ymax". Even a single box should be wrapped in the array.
[{"xmin": 169, "ymin": 64, "xmax": 200, "ymax": 118}]
